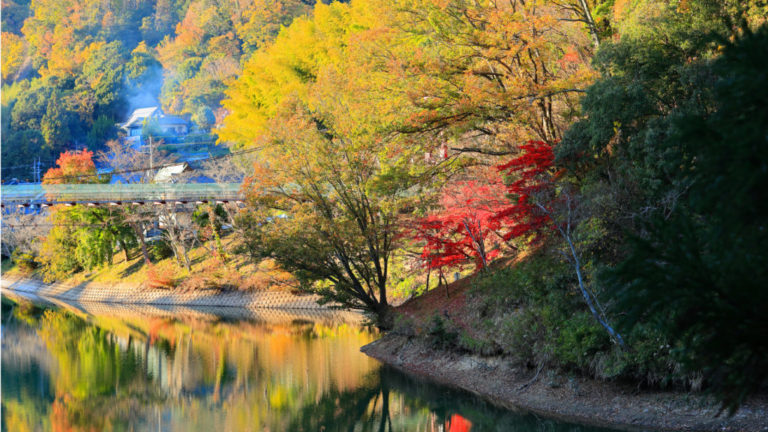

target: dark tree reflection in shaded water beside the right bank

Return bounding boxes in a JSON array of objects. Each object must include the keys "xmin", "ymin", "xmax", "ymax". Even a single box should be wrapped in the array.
[{"xmin": 287, "ymin": 366, "xmax": 604, "ymax": 432}]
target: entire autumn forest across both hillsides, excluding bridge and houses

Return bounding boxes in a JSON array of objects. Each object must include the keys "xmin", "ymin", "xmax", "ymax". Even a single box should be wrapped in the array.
[{"xmin": 2, "ymin": 0, "xmax": 768, "ymax": 426}]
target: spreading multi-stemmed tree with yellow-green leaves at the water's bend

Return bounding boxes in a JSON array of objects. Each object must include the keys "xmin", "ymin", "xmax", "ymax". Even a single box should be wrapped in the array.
[{"xmin": 241, "ymin": 96, "xmax": 411, "ymax": 327}]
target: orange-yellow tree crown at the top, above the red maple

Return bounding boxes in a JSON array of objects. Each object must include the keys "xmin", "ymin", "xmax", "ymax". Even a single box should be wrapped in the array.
[{"xmin": 393, "ymin": 0, "xmax": 595, "ymax": 156}]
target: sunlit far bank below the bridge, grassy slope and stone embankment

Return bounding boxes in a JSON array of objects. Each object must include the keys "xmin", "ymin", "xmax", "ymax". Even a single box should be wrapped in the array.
[{"xmin": 0, "ymin": 235, "xmax": 328, "ymax": 310}]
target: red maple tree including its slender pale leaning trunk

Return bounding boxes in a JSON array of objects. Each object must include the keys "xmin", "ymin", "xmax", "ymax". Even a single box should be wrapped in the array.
[{"xmin": 419, "ymin": 141, "xmax": 625, "ymax": 348}]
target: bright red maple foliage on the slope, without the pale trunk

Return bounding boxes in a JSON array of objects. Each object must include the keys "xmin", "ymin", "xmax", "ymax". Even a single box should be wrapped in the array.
[{"xmin": 414, "ymin": 141, "xmax": 555, "ymax": 268}]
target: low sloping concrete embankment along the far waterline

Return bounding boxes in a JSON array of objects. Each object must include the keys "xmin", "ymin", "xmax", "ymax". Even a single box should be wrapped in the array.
[{"xmin": 0, "ymin": 275, "xmax": 328, "ymax": 310}]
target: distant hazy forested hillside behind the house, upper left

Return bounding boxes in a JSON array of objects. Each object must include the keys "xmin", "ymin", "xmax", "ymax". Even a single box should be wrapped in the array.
[{"xmin": 2, "ymin": 0, "xmax": 314, "ymax": 179}]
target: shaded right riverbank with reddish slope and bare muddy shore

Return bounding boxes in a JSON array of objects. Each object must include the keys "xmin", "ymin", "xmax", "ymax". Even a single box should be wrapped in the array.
[{"xmin": 362, "ymin": 262, "xmax": 768, "ymax": 432}]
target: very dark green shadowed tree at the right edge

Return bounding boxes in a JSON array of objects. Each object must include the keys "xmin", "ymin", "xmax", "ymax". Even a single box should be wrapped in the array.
[{"xmin": 612, "ymin": 25, "xmax": 768, "ymax": 413}]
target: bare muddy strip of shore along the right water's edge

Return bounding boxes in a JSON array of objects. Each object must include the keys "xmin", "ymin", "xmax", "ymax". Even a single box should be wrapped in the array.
[{"xmin": 361, "ymin": 334, "xmax": 768, "ymax": 432}]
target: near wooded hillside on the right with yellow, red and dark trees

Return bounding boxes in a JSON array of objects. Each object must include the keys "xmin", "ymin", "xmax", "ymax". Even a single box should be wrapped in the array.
[{"xmin": 220, "ymin": 0, "xmax": 768, "ymax": 409}]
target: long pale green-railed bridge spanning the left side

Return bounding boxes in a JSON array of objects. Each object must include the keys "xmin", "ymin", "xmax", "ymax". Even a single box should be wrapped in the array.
[{"xmin": 0, "ymin": 183, "xmax": 245, "ymax": 208}]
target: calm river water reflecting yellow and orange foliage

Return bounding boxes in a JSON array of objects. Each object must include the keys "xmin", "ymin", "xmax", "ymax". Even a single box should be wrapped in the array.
[{"xmin": 2, "ymin": 297, "xmax": 616, "ymax": 432}]
